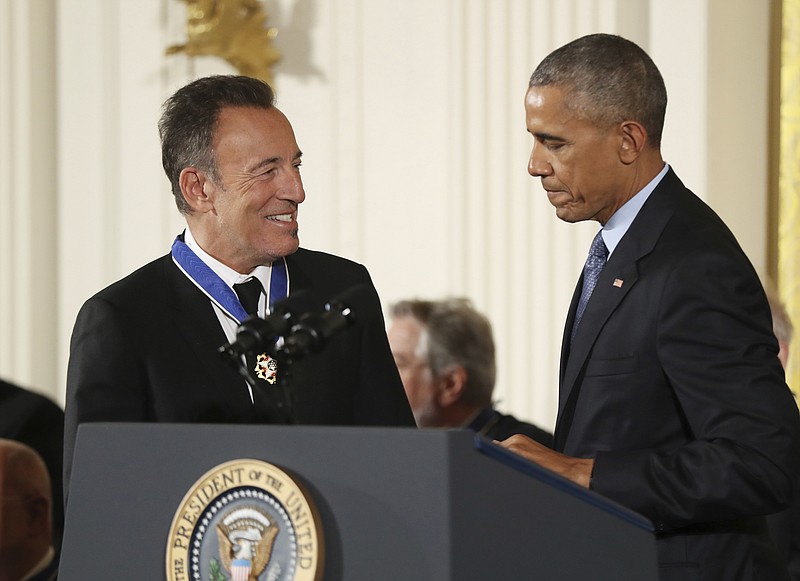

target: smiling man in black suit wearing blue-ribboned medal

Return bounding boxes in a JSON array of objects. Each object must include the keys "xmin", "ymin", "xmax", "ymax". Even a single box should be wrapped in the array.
[{"xmin": 65, "ymin": 76, "xmax": 414, "ymax": 494}]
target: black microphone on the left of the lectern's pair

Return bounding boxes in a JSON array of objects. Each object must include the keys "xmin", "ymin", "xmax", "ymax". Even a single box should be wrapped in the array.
[{"xmin": 217, "ymin": 290, "xmax": 315, "ymax": 365}]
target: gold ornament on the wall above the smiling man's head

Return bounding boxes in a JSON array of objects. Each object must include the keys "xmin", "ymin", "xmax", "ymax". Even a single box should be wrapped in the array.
[{"xmin": 166, "ymin": 0, "xmax": 280, "ymax": 84}]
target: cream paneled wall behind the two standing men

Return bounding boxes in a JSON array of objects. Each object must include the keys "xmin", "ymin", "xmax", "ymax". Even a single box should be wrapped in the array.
[{"xmin": 0, "ymin": 0, "xmax": 770, "ymax": 427}]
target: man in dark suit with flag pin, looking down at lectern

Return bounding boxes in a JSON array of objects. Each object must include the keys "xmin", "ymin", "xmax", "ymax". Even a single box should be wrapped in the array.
[{"xmin": 503, "ymin": 34, "xmax": 800, "ymax": 580}]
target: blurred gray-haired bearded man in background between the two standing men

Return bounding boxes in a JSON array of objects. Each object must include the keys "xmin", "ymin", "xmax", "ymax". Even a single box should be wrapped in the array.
[{"xmin": 389, "ymin": 298, "xmax": 552, "ymax": 446}]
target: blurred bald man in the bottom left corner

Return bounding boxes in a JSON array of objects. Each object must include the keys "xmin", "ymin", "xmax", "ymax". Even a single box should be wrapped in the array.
[{"xmin": 0, "ymin": 438, "xmax": 58, "ymax": 581}]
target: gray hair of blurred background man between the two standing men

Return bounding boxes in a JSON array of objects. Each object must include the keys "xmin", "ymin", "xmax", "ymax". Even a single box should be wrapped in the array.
[{"xmin": 390, "ymin": 298, "xmax": 497, "ymax": 406}]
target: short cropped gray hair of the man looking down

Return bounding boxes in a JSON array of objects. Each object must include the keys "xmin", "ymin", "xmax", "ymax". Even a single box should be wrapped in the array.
[{"xmin": 530, "ymin": 34, "xmax": 667, "ymax": 148}]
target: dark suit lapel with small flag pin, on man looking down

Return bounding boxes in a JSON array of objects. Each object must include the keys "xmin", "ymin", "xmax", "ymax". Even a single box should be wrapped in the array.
[{"xmin": 555, "ymin": 170, "xmax": 683, "ymax": 449}]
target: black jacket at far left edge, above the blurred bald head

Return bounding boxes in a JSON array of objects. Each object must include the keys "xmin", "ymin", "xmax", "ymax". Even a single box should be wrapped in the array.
[{"xmin": 0, "ymin": 380, "xmax": 64, "ymax": 548}]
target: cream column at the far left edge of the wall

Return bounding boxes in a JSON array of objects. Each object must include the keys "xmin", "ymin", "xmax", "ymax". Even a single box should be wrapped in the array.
[{"xmin": 0, "ymin": 0, "xmax": 59, "ymax": 395}]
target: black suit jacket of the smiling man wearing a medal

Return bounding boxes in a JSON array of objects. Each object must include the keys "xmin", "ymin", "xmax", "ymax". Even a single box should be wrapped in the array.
[{"xmin": 64, "ymin": 249, "xmax": 415, "ymax": 494}]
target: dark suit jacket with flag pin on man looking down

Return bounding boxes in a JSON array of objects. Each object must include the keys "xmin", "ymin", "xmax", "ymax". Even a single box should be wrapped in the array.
[{"xmin": 555, "ymin": 170, "xmax": 800, "ymax": 580}]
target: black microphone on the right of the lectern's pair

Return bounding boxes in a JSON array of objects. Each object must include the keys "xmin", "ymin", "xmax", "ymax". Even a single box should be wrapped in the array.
[{"xmin": 276, "ymin": 284, "xmax": 369, "ymax": 360}]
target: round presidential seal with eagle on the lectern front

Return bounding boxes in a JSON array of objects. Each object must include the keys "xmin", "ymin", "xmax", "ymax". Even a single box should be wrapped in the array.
[{"xmin": 166, "ymin": 460, "xmax": 324, "ymax": 581}]
